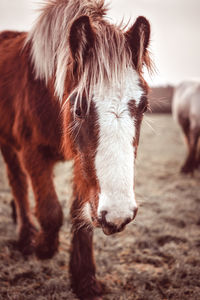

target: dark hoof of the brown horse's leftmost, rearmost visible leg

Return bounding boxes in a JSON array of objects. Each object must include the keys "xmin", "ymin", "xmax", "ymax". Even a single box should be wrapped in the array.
[{"xmin": 17, "ymin": 224, "xmax": 37, "ymax": 256}]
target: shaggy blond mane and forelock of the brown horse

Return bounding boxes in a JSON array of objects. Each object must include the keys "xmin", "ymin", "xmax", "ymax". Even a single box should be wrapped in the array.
[{"xmin": 27, "ymin": 0, "xmax": 135, "ymax": 100}]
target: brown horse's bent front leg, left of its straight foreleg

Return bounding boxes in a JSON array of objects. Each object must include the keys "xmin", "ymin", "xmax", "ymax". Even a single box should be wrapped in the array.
[{"xmin": 23, "ymin": 148, "xmax": 63, "ymax": 259}]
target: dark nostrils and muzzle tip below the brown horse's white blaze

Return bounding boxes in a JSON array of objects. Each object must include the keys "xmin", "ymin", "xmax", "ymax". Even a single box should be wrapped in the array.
[{"xmin": 99, "ymin": 207, "xmax": 138, "ymax": 235}]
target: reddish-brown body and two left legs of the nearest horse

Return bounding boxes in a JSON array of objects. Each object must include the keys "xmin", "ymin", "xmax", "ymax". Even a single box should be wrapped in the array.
[{"xmin": 0, "ymin": 33, "xmax": 62, "ymax": 257}]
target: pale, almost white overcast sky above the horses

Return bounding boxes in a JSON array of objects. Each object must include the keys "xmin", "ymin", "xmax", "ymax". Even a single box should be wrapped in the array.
[{"xmin": 0, "ymin": 0, "xmax": 200, "ymax": 85}]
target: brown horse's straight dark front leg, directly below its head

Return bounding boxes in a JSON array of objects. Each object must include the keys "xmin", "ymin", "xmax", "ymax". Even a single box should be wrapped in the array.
[{"xmin": 70, "ymin": 199, "xmax": 103, "ymax": 300}]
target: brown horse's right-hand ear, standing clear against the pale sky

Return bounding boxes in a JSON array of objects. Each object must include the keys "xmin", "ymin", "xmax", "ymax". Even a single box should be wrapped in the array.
[{"xmin": 125, "ymin": 17, "xmax": 151, "ymax": 72}]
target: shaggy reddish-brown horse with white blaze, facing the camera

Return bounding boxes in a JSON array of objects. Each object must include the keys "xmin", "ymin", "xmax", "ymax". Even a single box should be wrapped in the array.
[{"xmin": 0, "ymin": 0, "xmax": 151, "ymax": 299}]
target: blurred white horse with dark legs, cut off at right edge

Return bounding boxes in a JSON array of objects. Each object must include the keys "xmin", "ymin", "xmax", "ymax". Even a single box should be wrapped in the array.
[{"xmin": 172, "ymin": 82, "xmax": 200, "ymax": 173}]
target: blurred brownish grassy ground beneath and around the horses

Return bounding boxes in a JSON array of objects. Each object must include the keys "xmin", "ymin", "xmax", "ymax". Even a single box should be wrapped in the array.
[{"xmin": 0, "ymin": 114, "xmax": 200, "ymax": 300}]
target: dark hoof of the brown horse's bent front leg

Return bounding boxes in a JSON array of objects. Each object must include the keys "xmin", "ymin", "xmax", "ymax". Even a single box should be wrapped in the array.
[{"xmin": 35, "ymin": 232, "xmax": 59, "ymax": 259}]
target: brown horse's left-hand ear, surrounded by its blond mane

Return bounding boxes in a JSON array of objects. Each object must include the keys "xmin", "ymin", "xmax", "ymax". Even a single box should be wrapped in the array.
[{"xmin": 69, "ymin": 15, "xmax": 94, "ymax": 62}]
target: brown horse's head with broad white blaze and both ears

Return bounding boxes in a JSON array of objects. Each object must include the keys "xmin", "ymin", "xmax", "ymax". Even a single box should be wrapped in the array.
[{"xmin": 64, "ymin": 16, "xmax": 150, "ymax": 234}]
